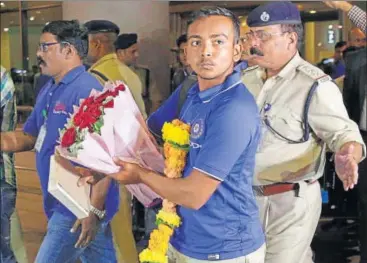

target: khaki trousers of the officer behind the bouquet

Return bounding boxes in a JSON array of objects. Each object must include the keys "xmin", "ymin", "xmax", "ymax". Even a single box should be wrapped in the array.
[{"xmin": 111, "ymin": 185, "xmax": 139, "ymax": 263}]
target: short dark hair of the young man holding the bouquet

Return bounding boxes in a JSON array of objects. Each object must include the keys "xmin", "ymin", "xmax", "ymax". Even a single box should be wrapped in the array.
[{"xmin": 187, "ymin": 6, "xmax": 240, "ymax": 44}]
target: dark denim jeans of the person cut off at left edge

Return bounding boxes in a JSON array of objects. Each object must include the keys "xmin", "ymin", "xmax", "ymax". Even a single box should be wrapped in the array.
[{"xmin": 0, "ymin": 180, "xmax": 17, "ymax": 263}]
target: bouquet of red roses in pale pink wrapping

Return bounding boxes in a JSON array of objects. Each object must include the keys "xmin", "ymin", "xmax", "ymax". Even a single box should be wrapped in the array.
[{"xmin": 57, "ymin": 82, "xmax": 164, "ymax": 206}]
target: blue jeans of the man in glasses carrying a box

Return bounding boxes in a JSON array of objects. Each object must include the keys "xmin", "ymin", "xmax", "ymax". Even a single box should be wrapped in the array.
[{"xmin": 35, "ymin": 212, "xmax": 117, "ymax": 263}]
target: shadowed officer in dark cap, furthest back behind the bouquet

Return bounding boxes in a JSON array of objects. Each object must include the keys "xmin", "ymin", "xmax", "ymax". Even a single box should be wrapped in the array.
[{"xmin": 115, "ymin": 33, "xmax": 162, "ymax": 114}]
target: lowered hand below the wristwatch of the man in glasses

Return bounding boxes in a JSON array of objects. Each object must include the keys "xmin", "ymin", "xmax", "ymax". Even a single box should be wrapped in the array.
[{"xmin": 70, "ymin": 213, "xmax": 100, "ymax": 248}]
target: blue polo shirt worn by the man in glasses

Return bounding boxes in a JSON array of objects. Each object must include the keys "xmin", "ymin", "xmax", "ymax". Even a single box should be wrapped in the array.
[{"xmin": 23, "ymin": 66, "xmax": 119, "ymax": 220}]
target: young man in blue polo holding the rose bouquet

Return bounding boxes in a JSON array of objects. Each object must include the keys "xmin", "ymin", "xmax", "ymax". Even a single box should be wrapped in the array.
[{"xmin": 105, "ymin": 7, "xmax": 265, "ymax": 263}]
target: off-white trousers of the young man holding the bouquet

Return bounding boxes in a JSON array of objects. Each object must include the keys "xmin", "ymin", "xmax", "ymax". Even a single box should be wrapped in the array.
[{"xmin": 167, "ymin": 244, "xmax": 265, "ymax": 263}]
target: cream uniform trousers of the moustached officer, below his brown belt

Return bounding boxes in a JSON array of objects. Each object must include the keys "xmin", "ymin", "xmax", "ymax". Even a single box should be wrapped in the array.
[{"xmin": 256, "ymin": 182, "xmax": 322, "ymax": 263}]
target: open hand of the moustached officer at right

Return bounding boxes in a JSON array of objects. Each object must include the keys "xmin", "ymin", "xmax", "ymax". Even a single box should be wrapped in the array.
[{"xmin": 335, "ymin": 144, "xmax": 358, "ymax": 191}]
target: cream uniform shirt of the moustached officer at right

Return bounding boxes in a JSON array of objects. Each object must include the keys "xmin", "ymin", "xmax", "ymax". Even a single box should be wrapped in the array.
[{"xmin": 242, "ymin": 53, "xmax": 366, "ymax": 185}]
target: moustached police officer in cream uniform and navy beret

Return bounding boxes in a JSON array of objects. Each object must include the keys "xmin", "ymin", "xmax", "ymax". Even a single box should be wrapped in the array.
[{"xmin": 243, "ymin": 2, "xmax": 367, "ymax": 263}]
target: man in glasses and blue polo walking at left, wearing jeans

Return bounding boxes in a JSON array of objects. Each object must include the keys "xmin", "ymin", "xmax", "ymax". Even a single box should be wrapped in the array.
[{"xmin": 1, "ymin": 21, "xmax": 119, "ymax": 263}]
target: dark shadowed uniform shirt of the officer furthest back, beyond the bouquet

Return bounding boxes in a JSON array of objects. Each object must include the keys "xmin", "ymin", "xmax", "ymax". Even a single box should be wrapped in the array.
[{"xmin": 130, "ymin": 65, "xmax": 162, "ymax": 112}]
